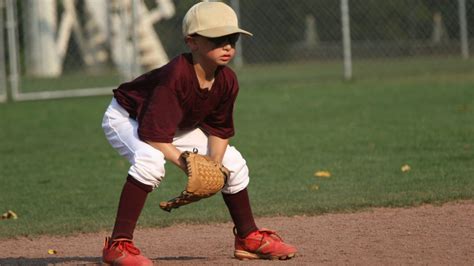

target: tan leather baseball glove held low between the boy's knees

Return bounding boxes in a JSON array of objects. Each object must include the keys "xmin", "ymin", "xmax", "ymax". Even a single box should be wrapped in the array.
[{"xmin": 160, "ymin": 151, "xmax": 230, "ymax": 212}]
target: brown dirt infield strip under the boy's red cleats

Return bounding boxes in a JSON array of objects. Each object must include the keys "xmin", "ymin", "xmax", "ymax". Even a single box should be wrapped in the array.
[{"xmin": 0, "ymin": 201, "xmax": 474, "ymax": 265}]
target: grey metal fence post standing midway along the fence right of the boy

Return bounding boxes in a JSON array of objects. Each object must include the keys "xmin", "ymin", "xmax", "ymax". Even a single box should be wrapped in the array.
[{"xmin": 341, "ymin": 0, "xmax": 352, "ymax": 80}]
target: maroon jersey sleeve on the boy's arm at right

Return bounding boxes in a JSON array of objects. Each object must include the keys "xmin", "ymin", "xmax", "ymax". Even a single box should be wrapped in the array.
[{"xmin": 200, "ymin": 79, "xmax": 239, "ymax": 139}]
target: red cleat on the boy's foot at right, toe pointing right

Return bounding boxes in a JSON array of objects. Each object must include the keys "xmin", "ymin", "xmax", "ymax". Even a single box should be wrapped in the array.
[{"xmin": 234, "ymin": 228, "xmax": 296, "ymax": 260}]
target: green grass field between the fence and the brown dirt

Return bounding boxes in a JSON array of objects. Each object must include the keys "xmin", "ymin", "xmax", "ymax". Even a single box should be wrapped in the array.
[{"xmin": 0, "ymin": 59, "xmax": 474, "ymax": 238}]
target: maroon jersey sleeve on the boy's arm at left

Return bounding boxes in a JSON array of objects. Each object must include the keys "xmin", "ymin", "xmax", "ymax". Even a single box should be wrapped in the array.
[{"xmin": 138, "ymin": 86, "xmax": 183, "ymax": 143}]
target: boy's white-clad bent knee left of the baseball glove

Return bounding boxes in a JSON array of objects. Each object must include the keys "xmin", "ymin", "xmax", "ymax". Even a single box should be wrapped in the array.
[{"xmin": 128, "ymin": 147, "xmax": 165, "ymax": 188}]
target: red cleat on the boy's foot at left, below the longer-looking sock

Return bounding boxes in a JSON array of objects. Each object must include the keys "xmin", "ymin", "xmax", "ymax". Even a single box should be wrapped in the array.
[{"xmin": 102, "ymin": 237, "xmax": 153, "ymax": 266}]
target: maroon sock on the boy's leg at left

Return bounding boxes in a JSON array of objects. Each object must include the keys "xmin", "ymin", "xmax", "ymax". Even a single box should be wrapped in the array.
[{"xmin": 112, "ymin": 175, "xmax": 153, "ymax": 239}]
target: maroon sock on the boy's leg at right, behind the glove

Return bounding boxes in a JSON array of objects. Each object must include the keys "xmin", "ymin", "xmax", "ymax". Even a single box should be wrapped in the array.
[{"xmin": 222, "ymin": 189, "xmax": 258, "ymax": 238}]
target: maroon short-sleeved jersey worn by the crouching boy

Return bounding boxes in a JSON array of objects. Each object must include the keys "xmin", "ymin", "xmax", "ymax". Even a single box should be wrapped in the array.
[{"xmin": 113, "ymin": 54, "xmax": 239, "ymax": 143}]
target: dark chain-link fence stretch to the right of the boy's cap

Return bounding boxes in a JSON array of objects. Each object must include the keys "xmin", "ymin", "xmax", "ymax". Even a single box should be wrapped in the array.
[{"xmin": 239, "ymin": 0, "xmax": 474, "ymax": 63}]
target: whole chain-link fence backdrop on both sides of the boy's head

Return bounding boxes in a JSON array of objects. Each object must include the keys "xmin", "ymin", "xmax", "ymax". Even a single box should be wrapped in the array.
[{"xmin": 0, "ymin": 0, "xmax": 474, "ymax": 100}]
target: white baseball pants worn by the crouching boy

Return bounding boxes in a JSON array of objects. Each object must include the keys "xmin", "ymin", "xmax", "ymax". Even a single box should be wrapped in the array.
[{"xmin": 102, "ymin": 98, "xmax": 249, "ymax": 194}]
